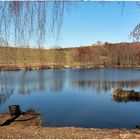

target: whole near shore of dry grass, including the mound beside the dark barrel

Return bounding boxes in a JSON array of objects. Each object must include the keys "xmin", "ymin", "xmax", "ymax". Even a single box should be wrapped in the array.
[{"xmin": 0, "ymin": 114, "xmax": 140, "ymax": 139}]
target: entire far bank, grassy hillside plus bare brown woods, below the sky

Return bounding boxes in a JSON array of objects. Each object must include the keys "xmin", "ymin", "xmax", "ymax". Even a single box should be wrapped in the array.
[{"xmin": 0, "ymin": 42, "xmax": 140, "ymax": 69}]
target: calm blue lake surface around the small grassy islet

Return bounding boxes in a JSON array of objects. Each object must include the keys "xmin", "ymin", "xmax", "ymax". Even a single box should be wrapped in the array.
[{"xmin": 0, "ymin": 68, "xmax": 140, "ymax": 128}]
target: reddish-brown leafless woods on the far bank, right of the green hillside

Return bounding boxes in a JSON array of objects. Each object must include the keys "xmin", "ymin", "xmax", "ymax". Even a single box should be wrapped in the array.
[{"xmin": 71, "ymin": 43, "xmax": 140, "ymax": 67}]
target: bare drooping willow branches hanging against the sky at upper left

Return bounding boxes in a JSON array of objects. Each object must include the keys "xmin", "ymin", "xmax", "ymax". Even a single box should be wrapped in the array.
[{"xmin": 0, "ymin": 1, "xmax": 69, "ymax": 47}]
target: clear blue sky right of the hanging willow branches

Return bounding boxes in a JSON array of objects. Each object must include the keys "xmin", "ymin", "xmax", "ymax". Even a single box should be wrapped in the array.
[{"xmin": 47, "ymin": 2, "xmax": 140, "ymax": 47}]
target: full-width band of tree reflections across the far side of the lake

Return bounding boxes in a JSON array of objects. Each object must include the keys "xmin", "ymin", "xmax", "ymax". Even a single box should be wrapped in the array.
[{"xmin": 0, "ymin": 70, "xmax": 140, "ymax": 104}]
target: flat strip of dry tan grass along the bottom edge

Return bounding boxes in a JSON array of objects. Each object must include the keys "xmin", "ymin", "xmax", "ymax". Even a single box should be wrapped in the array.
[{"xmin": 0, "ymin": 124, "xmax": 140, "ymax": 139}]
